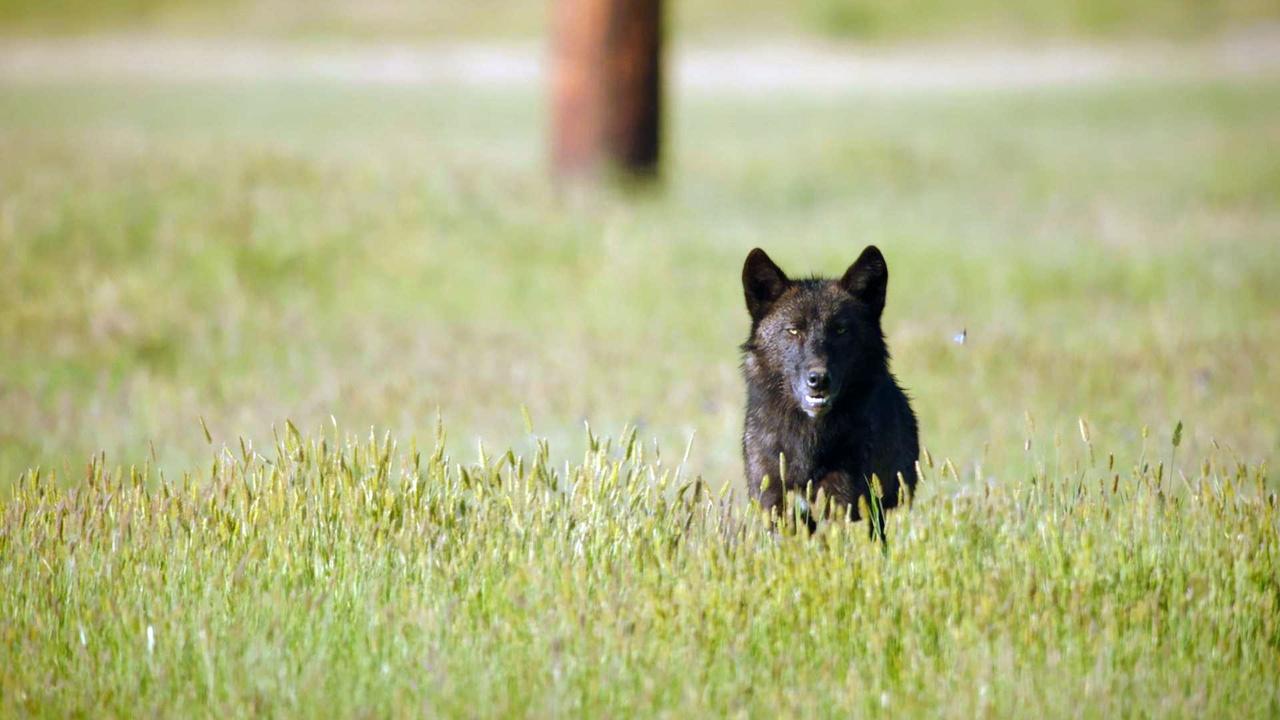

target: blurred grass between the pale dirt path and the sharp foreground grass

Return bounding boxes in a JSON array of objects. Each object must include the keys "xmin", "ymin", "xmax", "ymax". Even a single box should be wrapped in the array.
[{"xmin": 0, "ymin": 81, "xmax": 1280, "ymax": 482}]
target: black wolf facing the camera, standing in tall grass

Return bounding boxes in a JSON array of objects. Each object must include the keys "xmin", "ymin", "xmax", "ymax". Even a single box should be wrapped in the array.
[{"xmin": 742, "ymin": 246, "xmax": 919, "ymax": 533}]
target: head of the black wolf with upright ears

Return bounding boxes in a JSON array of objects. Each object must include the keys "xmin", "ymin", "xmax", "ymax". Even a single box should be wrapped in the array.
[{"xmin": 742, "ymin": 246, "xmax": 888, "ymax": 418}]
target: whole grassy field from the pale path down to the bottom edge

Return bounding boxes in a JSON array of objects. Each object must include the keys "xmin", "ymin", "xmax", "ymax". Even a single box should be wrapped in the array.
[{"xmin": 0, "ymin": 65, "xmax": 1280, "ymax": 717}]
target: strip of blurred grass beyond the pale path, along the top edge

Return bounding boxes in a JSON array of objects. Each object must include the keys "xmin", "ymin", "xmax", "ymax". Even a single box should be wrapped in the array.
[{"xmin": 0, "ymin": 0, "xmax": 1280, "ymax": 41}]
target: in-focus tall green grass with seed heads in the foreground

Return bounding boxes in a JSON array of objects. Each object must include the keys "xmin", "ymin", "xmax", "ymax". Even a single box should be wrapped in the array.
[{"xmin": 0, "ymin": 423, "xmax": 1280, "ymax": 717}]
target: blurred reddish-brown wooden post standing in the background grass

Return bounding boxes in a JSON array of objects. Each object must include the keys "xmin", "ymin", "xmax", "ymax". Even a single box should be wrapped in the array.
[{"xmin": 552, "ymin": 0, "xmax": 662, "ymax": 177}]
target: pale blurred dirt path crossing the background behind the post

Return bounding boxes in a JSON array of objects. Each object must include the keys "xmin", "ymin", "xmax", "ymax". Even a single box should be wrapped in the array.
[{"xmin": 0, "ymin": 27, "xmax": 1280, "ymax": 92}]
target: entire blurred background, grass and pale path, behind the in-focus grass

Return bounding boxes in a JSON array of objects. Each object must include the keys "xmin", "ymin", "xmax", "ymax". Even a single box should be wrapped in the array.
[{"xmin": 0, "ymin": 0, "xmax": 1280, "ymax": 486}]
